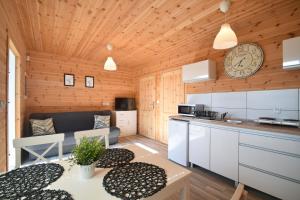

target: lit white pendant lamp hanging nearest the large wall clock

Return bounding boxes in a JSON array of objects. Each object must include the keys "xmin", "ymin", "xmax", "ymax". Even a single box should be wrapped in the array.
[{"xmin": 213, "ymin": 0, "xmax": 238, "ymax": 49}]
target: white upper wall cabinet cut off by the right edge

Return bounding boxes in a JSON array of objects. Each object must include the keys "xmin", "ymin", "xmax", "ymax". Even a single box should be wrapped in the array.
[{"xmin": 282, "ymin": 37, "xmax": 300, "ymax": 69}]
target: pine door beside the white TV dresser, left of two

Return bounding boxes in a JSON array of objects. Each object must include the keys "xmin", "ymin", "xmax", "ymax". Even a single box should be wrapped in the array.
[{"xmin": 138, "ymin": 75, "xmax": 156, "ymax": 139}]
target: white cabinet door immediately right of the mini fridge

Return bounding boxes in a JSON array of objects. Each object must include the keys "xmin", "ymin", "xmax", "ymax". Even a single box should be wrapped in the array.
[{"xmin": 189, "ymin": 124, "xmax": 210, "ymax": 169}]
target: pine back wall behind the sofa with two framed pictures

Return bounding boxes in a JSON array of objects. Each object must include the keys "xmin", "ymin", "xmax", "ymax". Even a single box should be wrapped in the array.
[{"xmin": 27, "ymin": 51, "xmax": 135, "ymax": 114}]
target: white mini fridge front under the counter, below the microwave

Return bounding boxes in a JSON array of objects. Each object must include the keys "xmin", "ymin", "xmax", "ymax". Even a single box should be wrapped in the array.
[{"xmin": 168, "ymin": 119, "xmax": 189, "ymax": 166}]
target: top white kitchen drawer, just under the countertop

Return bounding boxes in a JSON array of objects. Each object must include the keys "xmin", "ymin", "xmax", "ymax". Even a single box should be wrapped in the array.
[{"xmin": 240, "ymin": 132, "xmax": 300, "ymax": 155}]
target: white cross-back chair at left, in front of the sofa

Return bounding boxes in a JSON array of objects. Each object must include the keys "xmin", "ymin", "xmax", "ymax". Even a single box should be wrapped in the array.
[{"xmin": 13, "ymin": 133, "xmax": 65, "ymax": 168}]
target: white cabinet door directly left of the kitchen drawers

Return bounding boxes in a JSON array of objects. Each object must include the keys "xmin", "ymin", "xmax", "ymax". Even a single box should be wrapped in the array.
[{"xmin": 210, "ymin": 128, "xmax": 239, "ymax": 181}]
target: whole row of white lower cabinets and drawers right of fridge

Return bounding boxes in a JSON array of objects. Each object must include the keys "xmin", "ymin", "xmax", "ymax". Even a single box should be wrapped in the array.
[{"xmin": 189, "ymin": 124, "xmax": 300, "ymax": 200}]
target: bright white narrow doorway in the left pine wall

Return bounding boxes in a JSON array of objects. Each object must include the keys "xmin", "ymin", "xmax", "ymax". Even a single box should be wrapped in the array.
[{"xmin": 7, "ymin": 49, "xmax": 16, "ymax": 170}]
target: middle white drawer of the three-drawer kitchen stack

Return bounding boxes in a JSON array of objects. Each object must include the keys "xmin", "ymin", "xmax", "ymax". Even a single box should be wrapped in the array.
[{"xmin": 239, "ymin": 146, "xmax": 300, "ymax": 182}]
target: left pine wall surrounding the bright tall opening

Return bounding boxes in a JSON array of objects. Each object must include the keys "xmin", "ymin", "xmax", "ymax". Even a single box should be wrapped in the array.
[{"xmin": 0, "ymin": 1, "xmax": 26, "ymax": 172}]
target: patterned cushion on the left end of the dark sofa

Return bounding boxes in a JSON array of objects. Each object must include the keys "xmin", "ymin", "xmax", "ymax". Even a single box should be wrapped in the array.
[{"xmin": 30, "ymin": 118, "xmax": 55, "ymax": 136}]
